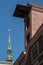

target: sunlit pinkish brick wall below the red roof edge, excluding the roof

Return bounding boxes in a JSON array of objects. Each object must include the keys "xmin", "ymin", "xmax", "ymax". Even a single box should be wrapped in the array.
[{"xmin": 31, "ymin": 10, "xmax": 43, "ymax": 37}]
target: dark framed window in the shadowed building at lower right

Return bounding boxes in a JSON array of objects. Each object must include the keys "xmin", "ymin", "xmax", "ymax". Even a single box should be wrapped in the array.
[{"xmin": 31, "ymin": 42, "xmax": 39, "ymax": 61}]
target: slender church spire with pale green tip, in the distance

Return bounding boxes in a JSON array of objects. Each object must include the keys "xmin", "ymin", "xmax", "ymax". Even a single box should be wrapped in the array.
[{"xmin": 6, "ymin": 29, "xmax": 12, "ymax": 62}]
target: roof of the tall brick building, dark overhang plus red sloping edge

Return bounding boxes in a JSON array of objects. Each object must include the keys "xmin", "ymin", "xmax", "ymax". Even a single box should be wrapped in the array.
[{"xmin": 13, "ymin": 3, "xmax": 43, "ymax": 18}]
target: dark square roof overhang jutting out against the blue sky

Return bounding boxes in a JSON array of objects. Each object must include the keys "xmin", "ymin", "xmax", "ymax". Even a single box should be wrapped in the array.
[{"xmin": 13, "ymin": 4, "xmax": 31, "ymax": 18}]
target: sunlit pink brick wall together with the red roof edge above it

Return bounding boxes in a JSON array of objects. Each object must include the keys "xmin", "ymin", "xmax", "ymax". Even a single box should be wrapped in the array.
[{"xmin": 27, "ymin": 4, "xmax": 43, "ymax": 37}]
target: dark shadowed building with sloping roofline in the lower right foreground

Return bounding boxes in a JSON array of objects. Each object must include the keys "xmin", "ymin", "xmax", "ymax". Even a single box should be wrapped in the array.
[{"xmin": 26, "ymin": 24, "xmax": 43, "ymax": 65}]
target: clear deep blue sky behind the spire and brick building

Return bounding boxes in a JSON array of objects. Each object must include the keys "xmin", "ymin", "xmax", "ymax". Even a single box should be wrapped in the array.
[{"xmin": 0, "ymin": 0, "xmax": 43, "ymax": 61}]
